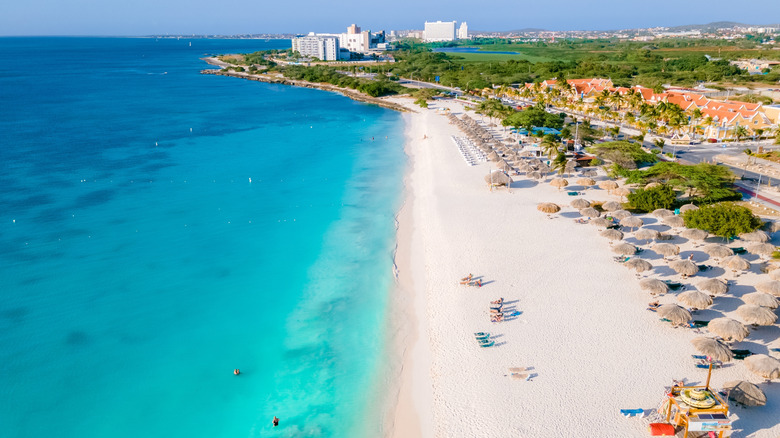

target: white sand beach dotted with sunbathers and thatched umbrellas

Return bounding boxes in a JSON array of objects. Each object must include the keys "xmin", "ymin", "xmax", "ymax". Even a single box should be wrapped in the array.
[{"xmin": 388, "ymin": 98, "xmax": 780, "ymax": 438}]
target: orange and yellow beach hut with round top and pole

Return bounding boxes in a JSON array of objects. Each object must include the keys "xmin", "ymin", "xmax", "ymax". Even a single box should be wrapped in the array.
[{"xmin": 663, "ymin": 366, "xmax": 731, "ymax": 438}]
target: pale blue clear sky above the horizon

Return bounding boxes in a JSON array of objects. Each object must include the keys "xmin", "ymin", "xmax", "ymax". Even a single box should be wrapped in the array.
[{"xmin": 0, "ymin": 0, "xmax": 780, "ymax": 36}]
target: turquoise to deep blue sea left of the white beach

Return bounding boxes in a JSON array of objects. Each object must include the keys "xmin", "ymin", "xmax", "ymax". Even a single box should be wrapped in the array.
[{"xmin": 0, "ymin": 38, "xmax": 405, "ymax": 438}]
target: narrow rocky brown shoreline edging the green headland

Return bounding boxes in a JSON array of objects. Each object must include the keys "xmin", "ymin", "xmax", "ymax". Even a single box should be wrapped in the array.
[{"xmin": 200, "ymin": 57, "xmax": 414, "ymax": 113}]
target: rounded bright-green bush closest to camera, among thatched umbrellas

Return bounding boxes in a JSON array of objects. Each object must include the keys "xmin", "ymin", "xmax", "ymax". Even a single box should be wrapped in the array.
[{"xmin": 683, "ymin": 202, "xmax": 761, "ymax": 238}]
